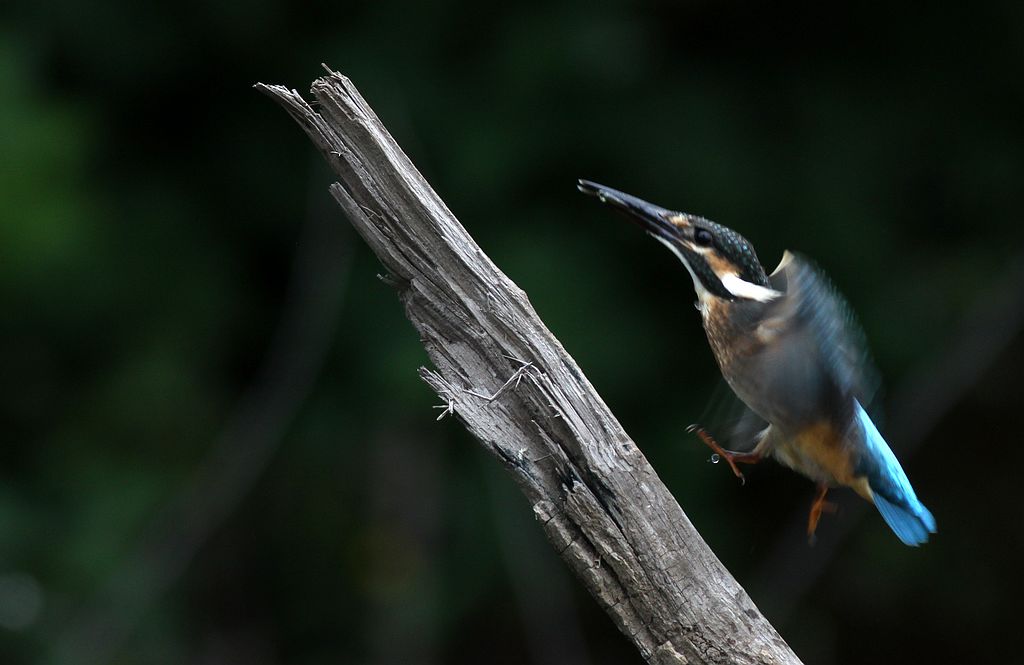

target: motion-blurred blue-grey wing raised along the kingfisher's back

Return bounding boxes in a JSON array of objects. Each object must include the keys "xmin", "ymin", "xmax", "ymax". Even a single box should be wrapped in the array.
[{"xmin": 763, "ymin": 252, "xmax": 879, "ymax": 405}]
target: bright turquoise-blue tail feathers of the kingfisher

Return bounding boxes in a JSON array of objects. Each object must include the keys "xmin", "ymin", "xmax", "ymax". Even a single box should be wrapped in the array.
[{"xmin": 856, "ymin": 403, "xmax": 936, "ymax": 546}]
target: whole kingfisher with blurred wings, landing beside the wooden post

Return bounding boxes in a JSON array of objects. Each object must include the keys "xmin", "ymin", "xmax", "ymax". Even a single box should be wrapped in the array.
[{"xmin": 578, "ymin": 180, "xmax": 936, "ymax": 546}]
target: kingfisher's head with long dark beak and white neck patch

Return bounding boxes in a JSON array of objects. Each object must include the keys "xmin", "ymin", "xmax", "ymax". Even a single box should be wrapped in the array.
[{"xmin": 577, "ymin": 180, "xmax": 780, "ymax": 302}]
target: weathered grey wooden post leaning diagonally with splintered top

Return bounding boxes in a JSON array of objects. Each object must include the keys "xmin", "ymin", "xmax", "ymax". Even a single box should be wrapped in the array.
[{"xmin": 256, "ymin": 70, "xmax": 800, "ymax": 664}]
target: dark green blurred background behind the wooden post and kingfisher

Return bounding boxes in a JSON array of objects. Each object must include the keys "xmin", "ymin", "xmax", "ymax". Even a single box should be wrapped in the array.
[{"xmin": 0, "ymin": 0, "xmax": 1024, "ymax": 665}]
